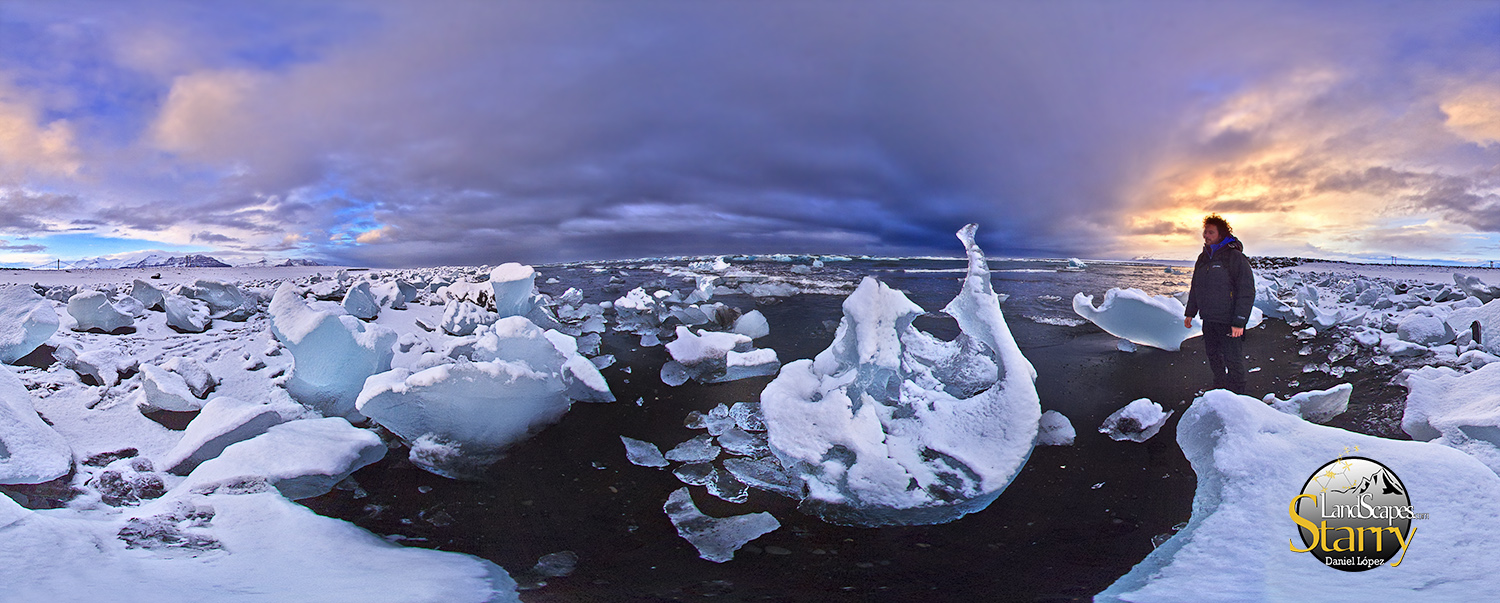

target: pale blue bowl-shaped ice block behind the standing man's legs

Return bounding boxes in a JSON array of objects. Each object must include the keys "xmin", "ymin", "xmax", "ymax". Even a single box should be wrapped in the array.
[{"xmin": 1073, "ymin": 288, "xmax": 1265, "ymax": 351}]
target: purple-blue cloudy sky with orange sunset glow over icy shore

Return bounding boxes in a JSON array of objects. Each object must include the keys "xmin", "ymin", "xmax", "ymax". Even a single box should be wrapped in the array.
[{"xmin": 0, "ymin": 0, "xmax": 1500, "ymax": 266}]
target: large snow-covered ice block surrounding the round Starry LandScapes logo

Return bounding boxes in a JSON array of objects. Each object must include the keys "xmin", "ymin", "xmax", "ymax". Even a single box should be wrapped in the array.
[{"xmin": 1095, "ymin": 390, "xmax": 1500, "ymax": 603}]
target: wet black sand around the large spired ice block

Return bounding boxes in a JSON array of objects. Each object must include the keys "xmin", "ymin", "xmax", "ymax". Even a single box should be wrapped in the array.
[{"xmin": 302, "ymin": 289, "xmax": 1406, "ymax": 602}]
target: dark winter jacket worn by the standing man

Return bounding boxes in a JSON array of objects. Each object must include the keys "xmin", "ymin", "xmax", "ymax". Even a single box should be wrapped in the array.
[{"xmin": 1187, "ymin": 237, "xmax": 1256, "ymax": 329}]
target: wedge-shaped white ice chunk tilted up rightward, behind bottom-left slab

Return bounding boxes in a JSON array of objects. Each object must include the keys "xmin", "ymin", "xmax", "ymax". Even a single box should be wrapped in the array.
[{"xmin": 156, "ymin": 396, "xmax": 282, "ymax": 476}]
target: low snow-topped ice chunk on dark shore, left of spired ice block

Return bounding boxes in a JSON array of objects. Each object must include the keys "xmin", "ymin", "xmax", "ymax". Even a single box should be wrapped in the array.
[{"xmin": 662, "ymin": 326, "xmax": 782, "ymax": 386}]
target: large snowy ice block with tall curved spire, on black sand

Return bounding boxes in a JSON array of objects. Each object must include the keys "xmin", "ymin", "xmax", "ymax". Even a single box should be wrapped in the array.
[{"xmin": 761, "ymin": 224, "xmax": 1041, "ymax": 525}]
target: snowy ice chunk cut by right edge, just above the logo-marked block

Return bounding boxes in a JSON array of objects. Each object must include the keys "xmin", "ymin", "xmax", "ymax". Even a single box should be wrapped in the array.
[{"xmin": 1401, "ymin": 365, "xmax": 1500, "ymax": 474}]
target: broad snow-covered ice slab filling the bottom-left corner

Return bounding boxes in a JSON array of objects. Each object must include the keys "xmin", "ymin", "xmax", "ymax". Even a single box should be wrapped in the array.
[{"xmin": 0, "ymin": 492, "xmax": 519, "ymax": 603}]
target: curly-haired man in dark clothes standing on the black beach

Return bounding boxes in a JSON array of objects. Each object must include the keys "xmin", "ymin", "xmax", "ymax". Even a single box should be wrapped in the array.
[{"xmin": 1182, "ymin": 213, "xmax": 1256, "ymax": 393}]
